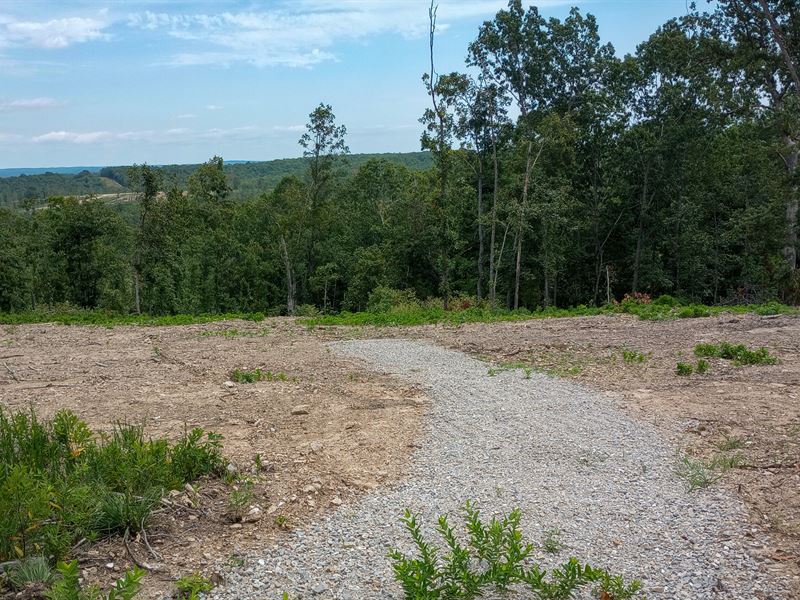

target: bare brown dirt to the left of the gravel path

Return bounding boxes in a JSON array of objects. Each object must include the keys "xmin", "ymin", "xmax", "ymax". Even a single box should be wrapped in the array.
[{"xmin": 0, "ymin": 319, "xmax": 426, "ymax": 597}]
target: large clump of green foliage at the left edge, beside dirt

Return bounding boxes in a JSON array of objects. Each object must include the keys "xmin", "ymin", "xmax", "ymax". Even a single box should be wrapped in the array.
[{"xmin": 0, "ymin": 409, "xmax": 224, "ymax": 562}]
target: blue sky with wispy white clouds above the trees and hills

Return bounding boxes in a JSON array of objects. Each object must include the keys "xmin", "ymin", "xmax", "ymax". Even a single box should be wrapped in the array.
[{"xmin": 0, "ymin": 0, "xmax": 688, "ymax": 168}]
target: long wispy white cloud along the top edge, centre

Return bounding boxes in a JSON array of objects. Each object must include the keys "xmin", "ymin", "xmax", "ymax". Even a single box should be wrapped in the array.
[{"xmin": 128, "ymin": 0, "xmax": 575, "ymax": 67}]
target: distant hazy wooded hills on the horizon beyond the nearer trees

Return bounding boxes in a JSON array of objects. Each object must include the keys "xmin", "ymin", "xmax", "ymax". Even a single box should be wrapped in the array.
[{"xmin": 0, "ymin": 152, "xmax": 432, "ymax": 207}]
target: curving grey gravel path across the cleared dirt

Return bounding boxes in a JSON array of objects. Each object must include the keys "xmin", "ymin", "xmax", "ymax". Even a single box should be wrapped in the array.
[{"xmin": 211, "ymin": 340, "xmax": 789, "ymax": 600}]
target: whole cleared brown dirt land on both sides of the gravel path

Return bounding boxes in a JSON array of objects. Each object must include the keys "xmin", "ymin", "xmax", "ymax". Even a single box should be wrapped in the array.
[{"xmin": 0, "ymin": 315, "xmax": 800, "ymax": 597}]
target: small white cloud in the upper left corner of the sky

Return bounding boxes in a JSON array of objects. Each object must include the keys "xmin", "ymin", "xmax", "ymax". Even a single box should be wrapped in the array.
[{"xmin": 0, "ymin": 17, "xmax": 108, "ymax": 49}]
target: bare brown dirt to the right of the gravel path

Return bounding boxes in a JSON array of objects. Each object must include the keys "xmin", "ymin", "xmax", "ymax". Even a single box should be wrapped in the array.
[{"xmin": 400, "ymin": 314, "xmax": 800, "ymax": 598}]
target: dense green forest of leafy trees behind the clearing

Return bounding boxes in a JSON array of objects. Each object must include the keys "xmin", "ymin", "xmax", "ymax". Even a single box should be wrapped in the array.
[{"xmin": 0, "ymin": 0, "xmax": 800, "ymax": 315}]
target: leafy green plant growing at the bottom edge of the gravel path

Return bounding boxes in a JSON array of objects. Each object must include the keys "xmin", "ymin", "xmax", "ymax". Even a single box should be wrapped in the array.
[{"xmin": 389, "ymin": 502, "xmax": 641, "ymax": 600}]
